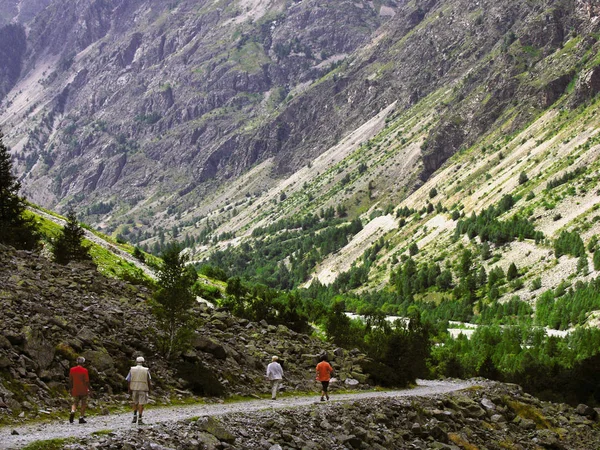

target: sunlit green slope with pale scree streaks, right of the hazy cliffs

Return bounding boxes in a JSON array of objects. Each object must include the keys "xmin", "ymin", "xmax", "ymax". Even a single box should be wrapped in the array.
[{"xmin": 175, "ymin": 1, "xmax": 600, "ymax": 301}]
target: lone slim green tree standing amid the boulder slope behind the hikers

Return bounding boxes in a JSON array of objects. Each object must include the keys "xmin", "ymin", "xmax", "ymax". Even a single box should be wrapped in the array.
[{"xmin": 152, "ymin": 244, "xmax": 198, "ymax": 358}]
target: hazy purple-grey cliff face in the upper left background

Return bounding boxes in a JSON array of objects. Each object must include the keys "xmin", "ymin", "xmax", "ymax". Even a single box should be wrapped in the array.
[{"xmin": 2, "ymin": 0, "xmax": 401, "ymax": 221}]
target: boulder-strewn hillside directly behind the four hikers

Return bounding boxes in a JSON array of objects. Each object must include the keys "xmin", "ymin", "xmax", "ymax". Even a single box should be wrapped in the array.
[{"xmin": 0, "ymin": 247, "xmax": 368, "ymax": 422}]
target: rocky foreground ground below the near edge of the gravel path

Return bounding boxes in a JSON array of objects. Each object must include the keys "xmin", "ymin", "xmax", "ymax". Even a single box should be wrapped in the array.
[{"xmin": 5, "ymin": 381, "xmax": 600, "ymax": 450}]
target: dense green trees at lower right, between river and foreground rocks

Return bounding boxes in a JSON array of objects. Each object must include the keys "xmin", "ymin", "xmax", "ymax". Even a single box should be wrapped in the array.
[{"xmin": 429, "ymin": 326, "xmax": 600, "ymax": 404}]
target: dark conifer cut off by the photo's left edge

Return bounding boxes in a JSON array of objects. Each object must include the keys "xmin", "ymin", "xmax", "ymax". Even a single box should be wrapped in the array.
[{"xmin": 0, "ymin": 133, "xmax": 39, "ymax": 250}]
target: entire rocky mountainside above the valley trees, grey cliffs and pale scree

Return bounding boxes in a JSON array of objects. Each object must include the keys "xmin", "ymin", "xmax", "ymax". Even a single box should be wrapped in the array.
[{"xmin": 0, "ymin": 0, "xmax": 600, "ymax": 312}]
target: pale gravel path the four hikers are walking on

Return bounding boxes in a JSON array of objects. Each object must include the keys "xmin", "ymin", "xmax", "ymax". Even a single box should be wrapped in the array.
[{"xmin": 0, "ymin": 380, "xmax": 472, "ymax": 449}]
